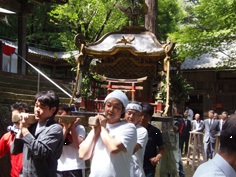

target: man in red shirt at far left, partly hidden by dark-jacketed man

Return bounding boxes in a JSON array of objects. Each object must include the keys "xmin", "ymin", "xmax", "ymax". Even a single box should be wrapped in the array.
[{"xmin": 0, "ymin": 102, "xmax": 29, "ymax": 177}]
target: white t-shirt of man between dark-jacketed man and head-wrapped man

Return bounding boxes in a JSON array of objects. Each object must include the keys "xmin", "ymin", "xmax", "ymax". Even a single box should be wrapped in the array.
[{"xmin": 57, "ymin": 125, "xmax": 85, "ymax": 171}]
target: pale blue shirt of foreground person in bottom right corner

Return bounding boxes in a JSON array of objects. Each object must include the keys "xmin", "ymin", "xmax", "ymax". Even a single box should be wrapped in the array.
[{"xmin": 193, "ymin": 153, "xmax": 236, "ymax": 177}]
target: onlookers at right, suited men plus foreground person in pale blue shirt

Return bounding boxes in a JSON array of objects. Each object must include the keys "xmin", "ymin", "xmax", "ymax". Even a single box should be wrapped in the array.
[{"xmin": 180, "ymin": 107, "xmax": 236, "ymax": 177}]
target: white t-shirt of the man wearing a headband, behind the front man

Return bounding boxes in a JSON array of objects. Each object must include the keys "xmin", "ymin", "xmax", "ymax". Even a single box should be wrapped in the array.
[{"xmin": 130, "ymin": 125, "xmax": 148, "ymax": 177}]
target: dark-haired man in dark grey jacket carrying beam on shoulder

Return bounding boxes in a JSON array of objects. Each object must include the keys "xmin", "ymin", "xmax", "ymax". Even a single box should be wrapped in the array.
[{"xmin": 12, "ymin": 91, "xmax": 64, "ymax": 177}]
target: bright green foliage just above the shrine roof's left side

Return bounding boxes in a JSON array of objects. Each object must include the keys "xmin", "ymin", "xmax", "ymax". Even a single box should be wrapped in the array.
[{"xmin": 49, "ymin": 0, "xmax": 127, "ymax": 50}]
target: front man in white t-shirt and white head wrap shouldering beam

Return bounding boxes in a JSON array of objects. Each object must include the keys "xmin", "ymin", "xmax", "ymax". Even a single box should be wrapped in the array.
[{"xmin": 79, "ymin": 90, "xmax": 137, "ymax": 177}]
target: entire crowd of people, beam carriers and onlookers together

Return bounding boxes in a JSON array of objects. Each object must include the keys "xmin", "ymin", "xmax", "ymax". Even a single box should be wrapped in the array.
[{"xmin": 0, "ymin": 90, "xmax": 236, "ymax": 177}]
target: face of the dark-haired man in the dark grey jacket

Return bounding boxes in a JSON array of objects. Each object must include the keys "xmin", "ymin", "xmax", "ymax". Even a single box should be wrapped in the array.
[{"xmin": 34, "ymin": 100, "xmax": 56, "ymax": 123}]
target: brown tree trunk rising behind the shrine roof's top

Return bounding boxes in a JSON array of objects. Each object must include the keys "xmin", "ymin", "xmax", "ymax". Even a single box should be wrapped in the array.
[{"xmin": 145, "ymin": 0, "xmax": 158, "ymax": 35}]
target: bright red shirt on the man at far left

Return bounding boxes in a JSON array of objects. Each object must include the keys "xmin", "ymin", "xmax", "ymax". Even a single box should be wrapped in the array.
[{"xmin": 0, "ymin": 131, "xmax": 23, "ymax": 177}]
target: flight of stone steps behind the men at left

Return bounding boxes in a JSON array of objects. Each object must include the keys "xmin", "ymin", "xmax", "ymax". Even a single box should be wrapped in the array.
[{"xmin": 0, "ymin": 72, "xmax": 72, "ymax": 107}]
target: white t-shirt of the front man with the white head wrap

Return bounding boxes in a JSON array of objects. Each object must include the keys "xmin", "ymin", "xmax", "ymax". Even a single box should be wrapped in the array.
[{"xmin": 89, "ymin": 122, "xmax": 137, "ymax": 177}]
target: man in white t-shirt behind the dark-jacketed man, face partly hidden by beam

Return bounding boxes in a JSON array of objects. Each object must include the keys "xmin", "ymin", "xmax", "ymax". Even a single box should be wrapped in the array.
[{"xmin": 57, "ymin": 104, "xmax": 85, "ymax": 177}]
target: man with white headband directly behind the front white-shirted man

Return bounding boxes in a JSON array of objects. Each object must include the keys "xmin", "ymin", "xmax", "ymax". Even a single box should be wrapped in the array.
[{"xmin": 125, "ymin": 102, "xmax": 148, "ymax": 177}]
